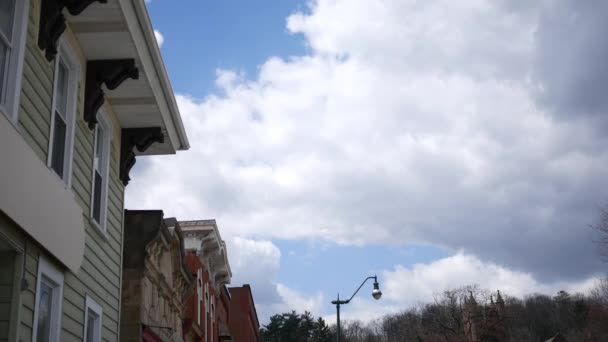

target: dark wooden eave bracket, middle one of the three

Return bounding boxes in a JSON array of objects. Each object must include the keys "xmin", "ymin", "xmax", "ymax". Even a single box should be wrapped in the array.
[{"xmin": 84, "ymin": 59, "xmax": 139, "ymax": 129}]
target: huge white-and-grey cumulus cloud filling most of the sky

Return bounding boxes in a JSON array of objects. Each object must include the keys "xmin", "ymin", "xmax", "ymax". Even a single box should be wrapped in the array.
[{"xmin": 127, "ymin": 0, "xmax": 608, "ymax": 316}]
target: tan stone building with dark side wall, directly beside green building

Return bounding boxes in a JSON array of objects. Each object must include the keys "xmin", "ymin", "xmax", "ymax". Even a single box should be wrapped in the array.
[{"xmin": 120, "ymin": 210, "xmax": 194, "ymax": 342}]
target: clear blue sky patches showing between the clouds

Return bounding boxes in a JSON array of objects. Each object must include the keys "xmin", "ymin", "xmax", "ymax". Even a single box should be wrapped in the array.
[{"xmin": 142, "ymin": 0, "xmax": 456, "ymax": 315}]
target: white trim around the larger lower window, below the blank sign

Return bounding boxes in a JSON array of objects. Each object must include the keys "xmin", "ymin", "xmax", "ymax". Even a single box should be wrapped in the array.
[{"xmin": 32, "ymin": 257, "xmax": 64, "ymax": 342}]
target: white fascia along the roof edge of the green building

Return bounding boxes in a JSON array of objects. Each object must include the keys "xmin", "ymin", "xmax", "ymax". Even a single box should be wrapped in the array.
[{"xmin": 119, "ymin": 0, "xmax": 190, "ymax": 150}]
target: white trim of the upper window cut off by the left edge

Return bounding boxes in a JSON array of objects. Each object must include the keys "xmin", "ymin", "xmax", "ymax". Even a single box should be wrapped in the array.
[{"xmin": 0, "ymin": 0, "xmax": 30, "ymax": 125}]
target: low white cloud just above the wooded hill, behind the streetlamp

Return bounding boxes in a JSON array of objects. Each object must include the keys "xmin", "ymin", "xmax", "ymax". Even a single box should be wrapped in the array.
[{"xmin": 325, "ymin": 251, "xmax": 599, "ymax": 322}]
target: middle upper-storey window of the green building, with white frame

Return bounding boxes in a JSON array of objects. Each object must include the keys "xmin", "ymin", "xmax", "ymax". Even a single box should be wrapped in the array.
[{"xmin": 48, "ymin": 39, "xmax": 80, "ymax": 187}]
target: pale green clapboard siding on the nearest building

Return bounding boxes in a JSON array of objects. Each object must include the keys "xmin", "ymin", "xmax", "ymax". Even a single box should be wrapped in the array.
[{"xmin": 10, "ymin": 0, "xmax": 124, "ymax": 342}]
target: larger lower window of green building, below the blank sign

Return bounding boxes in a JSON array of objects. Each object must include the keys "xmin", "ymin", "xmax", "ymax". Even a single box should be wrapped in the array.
[{"xmin": 32, "ymin": 257, "xmax": 63, "ymax": 342}]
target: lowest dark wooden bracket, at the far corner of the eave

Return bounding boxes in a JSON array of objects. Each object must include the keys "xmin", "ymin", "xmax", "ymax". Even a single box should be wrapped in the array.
[{"xmin": 119, "ymin": 127, "xmax": 165, "ymax": 186}]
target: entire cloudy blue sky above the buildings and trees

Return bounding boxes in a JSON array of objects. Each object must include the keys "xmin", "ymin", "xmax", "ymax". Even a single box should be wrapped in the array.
[{"xmin": 126, "ymin": 0, "xmax": 608, "ymax": 323}]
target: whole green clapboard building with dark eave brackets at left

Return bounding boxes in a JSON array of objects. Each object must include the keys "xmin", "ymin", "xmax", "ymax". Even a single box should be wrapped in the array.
[{"xmin": 0, "ymin": 0, "xmax": 188, "ymax": 341}]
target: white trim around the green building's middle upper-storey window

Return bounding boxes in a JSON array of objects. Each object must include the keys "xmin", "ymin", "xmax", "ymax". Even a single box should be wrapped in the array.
[{"xmin": 46, "ymin": 36, "xmax": 80, "ymax": 189}]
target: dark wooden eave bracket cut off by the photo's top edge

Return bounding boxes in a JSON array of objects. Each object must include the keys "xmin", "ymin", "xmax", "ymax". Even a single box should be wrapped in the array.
[{"xmin": 38, "ymin": 0, "xmax": 108, "ymax": 61}]
